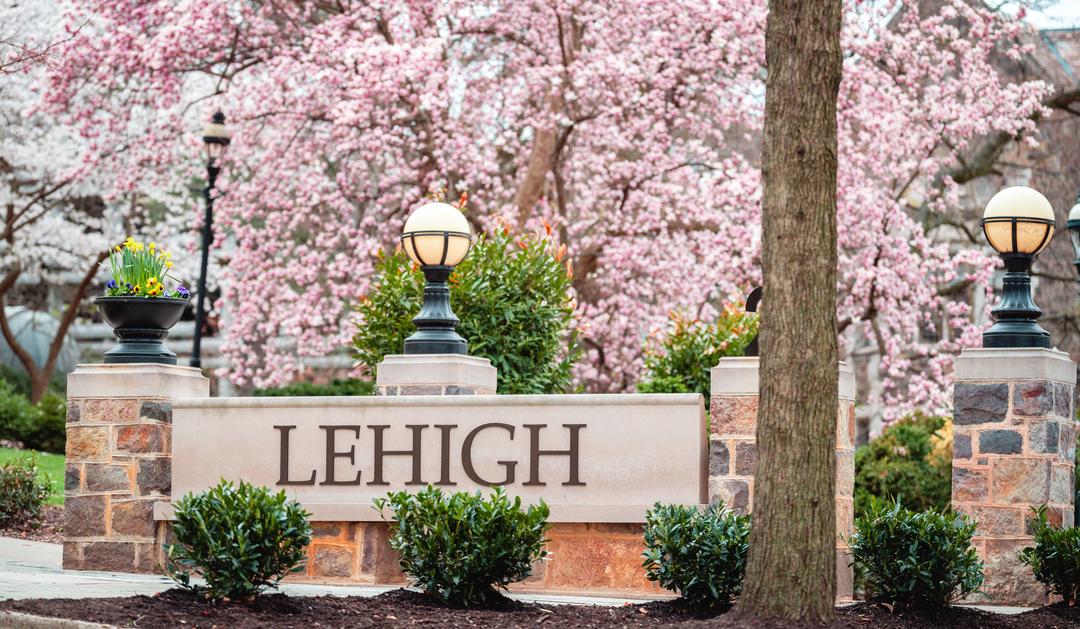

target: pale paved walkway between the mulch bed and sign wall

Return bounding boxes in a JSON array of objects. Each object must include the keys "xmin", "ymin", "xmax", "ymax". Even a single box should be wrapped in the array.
[{"xmin": 0, "ymin": 537, "xmax": 642, "ymax": 605}]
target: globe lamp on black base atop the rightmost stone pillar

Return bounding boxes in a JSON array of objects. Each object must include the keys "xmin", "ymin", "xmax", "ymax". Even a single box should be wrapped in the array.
[{"xmin": 983, "ymin": 186, "xmax": 1055, "ymax": 348}]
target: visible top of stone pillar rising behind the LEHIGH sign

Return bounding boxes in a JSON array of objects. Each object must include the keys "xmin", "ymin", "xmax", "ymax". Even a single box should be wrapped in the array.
[{"xmin": 375, "ymin": 353, "xmax": 498, "ymax": 396}]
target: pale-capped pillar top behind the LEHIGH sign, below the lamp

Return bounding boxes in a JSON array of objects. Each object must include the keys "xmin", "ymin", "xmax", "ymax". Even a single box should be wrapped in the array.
[{"xmin": 375, "ymin": 353, "xmax": 498, "ymax": 392}]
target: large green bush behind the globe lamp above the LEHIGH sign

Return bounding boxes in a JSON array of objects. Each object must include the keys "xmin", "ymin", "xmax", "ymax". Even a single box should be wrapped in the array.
[{"xmin": 353, "ymin": 230, "xmax": 580, "ymax": 393}]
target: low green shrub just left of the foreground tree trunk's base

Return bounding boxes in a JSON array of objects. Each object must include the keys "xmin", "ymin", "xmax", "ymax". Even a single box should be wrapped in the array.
[{"xmin": 643, "ymin": 503, "xmax": 751, "ymax": 607}]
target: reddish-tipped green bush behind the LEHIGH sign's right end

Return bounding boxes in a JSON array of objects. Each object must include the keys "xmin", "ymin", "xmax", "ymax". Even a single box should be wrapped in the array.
[{"xmin": 637, "ymin": 304, "xmax": 758, "ymax": 400}]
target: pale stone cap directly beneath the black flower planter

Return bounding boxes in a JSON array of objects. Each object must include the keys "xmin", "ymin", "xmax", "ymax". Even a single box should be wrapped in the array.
[{"xmin": 67, "ymin": 362, "xmax": 210, "ymax": 399}]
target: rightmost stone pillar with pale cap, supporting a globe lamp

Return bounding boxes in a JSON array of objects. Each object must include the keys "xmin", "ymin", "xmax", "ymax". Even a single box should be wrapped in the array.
[{"xmin": 953, "ymin": 348, "xmax": 1077, "ymax": 606}]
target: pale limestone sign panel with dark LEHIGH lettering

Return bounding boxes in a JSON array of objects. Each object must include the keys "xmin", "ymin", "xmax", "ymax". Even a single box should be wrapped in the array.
[{"xmin": 168, "ymin": 394, "xmax": 708, "ymax": 522}]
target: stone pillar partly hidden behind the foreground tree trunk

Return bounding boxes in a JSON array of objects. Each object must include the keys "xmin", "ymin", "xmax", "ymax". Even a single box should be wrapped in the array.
[{"xmin": 708, "ymin": 357, "xmax": 855, "ymax": 601}]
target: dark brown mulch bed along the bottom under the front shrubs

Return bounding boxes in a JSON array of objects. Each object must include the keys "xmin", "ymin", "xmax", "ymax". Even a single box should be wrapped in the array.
[{"xmin": 0, "ymin": 589, "xmax": 1080, "ymax": 629}]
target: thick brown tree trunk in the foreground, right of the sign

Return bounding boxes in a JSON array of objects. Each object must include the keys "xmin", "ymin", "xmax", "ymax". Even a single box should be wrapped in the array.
[{"xmin": 738, "ymin": 0, "xmax": 842, "ymax": 621}]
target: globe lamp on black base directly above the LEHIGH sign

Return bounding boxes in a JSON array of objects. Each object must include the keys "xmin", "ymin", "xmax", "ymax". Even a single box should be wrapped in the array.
[{"xmin": 402, "ymin": 202, "xmax": 473, "ymax": 353}]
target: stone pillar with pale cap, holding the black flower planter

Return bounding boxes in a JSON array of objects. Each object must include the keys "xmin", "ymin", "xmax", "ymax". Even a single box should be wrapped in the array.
[{"xmin": 64, "ymin": 363, "xmax": 210, "ymax": 572}]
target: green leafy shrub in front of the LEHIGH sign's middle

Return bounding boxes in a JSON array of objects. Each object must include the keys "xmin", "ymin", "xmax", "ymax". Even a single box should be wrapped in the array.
[{"xmin": 375, "ymin": 485, "xmax": 549, "ymax": 606}]
